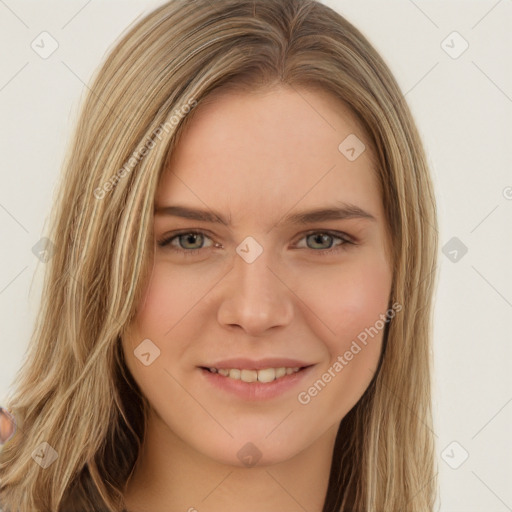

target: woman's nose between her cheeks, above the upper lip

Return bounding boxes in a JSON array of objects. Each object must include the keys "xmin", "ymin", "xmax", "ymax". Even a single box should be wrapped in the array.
[{"xmin": 217, "ymin": 244, "xmax": 294, "ymax": 336}]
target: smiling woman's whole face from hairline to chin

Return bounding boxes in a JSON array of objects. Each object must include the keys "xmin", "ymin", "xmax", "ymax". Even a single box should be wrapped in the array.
[{"xmin": 123, "ymin": 84, "xmax": 392, "ymax": 466}]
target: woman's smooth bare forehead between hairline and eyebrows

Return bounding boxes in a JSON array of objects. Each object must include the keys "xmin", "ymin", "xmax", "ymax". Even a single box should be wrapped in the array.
[{"xmin": 156, "ymin": 87, "xmax": 382, "ymax": 225}]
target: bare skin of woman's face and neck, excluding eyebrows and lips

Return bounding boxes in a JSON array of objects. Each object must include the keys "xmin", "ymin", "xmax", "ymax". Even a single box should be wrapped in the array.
[{"xmin": 122, "ymin": 86, "xmax": 392, "ymax": 512}]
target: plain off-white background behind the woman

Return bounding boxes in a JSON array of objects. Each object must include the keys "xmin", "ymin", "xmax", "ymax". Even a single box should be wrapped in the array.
[{"xmin": 0, "ymin": 0, "xmax": 512, "ymax": 512}]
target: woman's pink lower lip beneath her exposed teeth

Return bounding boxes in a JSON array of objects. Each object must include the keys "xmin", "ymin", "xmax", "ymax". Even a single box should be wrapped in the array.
[{"xmin": 200, "ymin": 365, "xmax": 314, "ymax": 401}]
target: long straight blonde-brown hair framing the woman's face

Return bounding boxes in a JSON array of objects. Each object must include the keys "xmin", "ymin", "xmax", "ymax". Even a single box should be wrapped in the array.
[{"xmin": 0, "ymin": 0, "xmax": 438, "ymax": 512}]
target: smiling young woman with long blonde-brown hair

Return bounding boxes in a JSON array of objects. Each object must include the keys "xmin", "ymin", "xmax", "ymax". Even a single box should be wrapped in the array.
[{"xmin": 0, "ymin": 0, "xmax": 437, "ymax": 512}]
